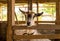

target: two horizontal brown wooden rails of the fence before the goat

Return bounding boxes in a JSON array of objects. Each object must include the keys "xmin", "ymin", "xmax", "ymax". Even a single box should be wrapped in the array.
[{"xmin": 12, "ymin": 24, "xmax": 60, "ymax": 40}]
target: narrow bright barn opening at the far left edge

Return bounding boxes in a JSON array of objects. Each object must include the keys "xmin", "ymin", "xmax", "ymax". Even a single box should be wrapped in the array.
[{"xmin": 0, "ymin": 3, "xmax": 7, "ymax": 21}]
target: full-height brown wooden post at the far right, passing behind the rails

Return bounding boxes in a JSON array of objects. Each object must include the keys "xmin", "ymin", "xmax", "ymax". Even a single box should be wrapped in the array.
[{"xmin": 54, "ymin": 0, "xmax": 60, "ymax": 41}]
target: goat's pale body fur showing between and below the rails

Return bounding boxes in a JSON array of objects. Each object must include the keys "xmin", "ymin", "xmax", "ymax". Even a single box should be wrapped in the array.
[{"xmin": 15, "ymin": 29, "xmax": 51, "ymax": 41}]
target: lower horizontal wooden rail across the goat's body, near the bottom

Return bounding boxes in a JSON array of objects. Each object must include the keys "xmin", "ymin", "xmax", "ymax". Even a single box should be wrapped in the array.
[{"xmin": 14, "ymin": 34, "xmax": 60, "ymax": 40}]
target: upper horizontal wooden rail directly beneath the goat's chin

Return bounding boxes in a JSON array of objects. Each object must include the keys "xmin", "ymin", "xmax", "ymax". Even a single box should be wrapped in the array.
[{"xmin": 13, "ymin": 24, "xmax": 60, "ymax": 30}]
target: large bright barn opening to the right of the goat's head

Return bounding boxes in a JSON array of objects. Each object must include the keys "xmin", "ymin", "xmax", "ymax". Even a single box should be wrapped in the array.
[{"xmin": 38, "ymin": 3, "xmax": 56, "ymax": 21}]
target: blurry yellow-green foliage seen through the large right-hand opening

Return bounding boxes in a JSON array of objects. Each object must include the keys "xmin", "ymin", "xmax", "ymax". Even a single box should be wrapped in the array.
[{"xmin": 42, "ymin": 4, "xmax": 56, "ymax": 14}]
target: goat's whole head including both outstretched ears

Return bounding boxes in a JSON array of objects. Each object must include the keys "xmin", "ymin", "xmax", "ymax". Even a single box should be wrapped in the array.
[{"xmin": 19, "ymin": 9, "xmax": 43, "ymax": 27}]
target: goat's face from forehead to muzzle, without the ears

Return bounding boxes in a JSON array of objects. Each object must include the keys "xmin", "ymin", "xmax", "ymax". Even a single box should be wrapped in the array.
[{"xmin": 26, "ymin": 11, "xmax": 35, "ymax": 26}]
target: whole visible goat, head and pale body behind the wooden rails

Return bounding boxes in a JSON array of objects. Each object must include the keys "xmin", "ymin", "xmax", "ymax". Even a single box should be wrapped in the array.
[{"xmin": 15, "ymin": 9, "xmax": 51, "ymax": 41}]
